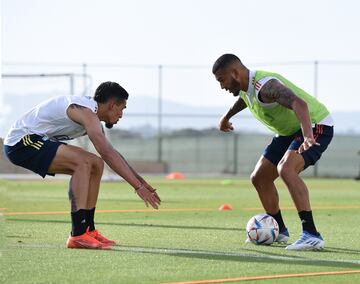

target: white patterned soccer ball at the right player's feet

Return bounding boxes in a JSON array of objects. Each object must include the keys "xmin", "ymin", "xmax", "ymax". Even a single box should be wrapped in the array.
[{"xmin": 246, "ymin": 214, "xmax": 279, "ymax": 245}]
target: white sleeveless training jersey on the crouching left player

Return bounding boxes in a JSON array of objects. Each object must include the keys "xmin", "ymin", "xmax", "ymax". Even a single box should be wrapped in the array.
[{"xmin": 4, "ymin": 96, "xmax": 98, "ymax": 146}]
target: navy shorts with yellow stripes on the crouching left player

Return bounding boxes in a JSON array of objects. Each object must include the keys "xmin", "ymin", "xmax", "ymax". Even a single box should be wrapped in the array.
[{"xmin": 4, "ymin": 134, "xmax": 66, "ymax": 178}]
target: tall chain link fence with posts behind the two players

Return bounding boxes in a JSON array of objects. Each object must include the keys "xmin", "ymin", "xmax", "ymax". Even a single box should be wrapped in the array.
[{"xmin": 0, "ymin": 61, "xmax": 360, "ymax": 177}]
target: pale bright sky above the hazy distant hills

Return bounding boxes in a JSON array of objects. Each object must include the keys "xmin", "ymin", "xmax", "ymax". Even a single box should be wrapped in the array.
[{"xmin": 1, "ymin": 0, "xmax": 360, "ymax": 114}]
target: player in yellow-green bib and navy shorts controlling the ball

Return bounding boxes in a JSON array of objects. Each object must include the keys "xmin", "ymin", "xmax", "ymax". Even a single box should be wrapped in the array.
[{"xmin": 212, "ymin": 54, "xmax": 334, "ymax": 250}]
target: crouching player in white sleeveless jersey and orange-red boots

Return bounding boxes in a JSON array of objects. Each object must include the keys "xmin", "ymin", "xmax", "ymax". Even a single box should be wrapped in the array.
[{"xmin": 4, "ymin": 82, "xmax": 161, "ymax": 249}]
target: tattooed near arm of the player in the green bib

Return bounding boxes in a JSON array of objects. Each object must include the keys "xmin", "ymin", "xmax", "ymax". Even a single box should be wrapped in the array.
[{"xmin": 259, "ymin": 79, "xmax": 320, "ymax": 153}]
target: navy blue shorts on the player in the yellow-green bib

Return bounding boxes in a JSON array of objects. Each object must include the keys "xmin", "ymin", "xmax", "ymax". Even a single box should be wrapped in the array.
[{"xmin": 264, "ymin": 124, "xmax": 334, "ymax": 169}]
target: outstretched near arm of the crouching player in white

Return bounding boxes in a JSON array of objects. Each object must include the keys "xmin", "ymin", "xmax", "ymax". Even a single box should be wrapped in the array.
[{"xmin": 67, "ymin": 107, "xmax": 161, "ymax": 209}]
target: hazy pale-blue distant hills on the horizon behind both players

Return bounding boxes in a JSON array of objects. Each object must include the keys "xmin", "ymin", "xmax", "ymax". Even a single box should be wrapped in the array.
[{"xmin": 0, "ymin": 93, "xmax": 360, "ymax": 137}]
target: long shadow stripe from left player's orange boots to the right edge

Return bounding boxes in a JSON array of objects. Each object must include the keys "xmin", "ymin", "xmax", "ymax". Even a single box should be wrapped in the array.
[{"xmin": 112, "ymin": 245, "xmax": 360, "ymax": 270}]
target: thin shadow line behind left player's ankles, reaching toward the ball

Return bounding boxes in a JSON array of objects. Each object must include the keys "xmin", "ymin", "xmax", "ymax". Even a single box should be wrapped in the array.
[{"xmin": 7, "ymin": 219, "xmax": 245, "ymax": 231}]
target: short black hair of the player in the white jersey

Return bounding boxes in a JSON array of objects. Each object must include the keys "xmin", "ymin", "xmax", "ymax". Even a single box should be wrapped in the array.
[{"xmin": 94, "ymin": 81, "xmax": 129, "ymax": 103}]
